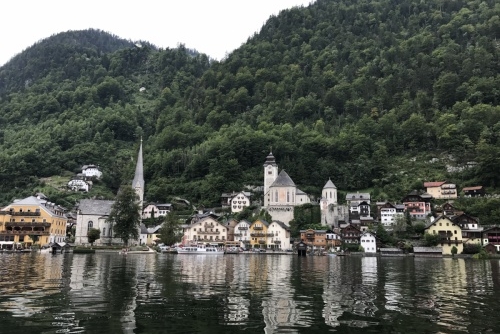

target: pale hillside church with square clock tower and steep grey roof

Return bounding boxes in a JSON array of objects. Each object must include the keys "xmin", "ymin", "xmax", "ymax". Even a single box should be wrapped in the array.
[{"xmin": 264, "ymin": 153, "xmax": 311, "ymax": 225}]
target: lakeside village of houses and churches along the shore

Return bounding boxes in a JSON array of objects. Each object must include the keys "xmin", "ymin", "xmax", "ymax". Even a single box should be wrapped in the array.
[{"xmin": 0, "ymin": 143, "xmax": 500, "ymax": 256}]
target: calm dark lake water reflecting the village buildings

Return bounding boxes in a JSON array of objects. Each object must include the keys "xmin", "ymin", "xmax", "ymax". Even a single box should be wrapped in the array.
[{"xmin": 0, "ymin": 253, "xmax": 500, "ymax": 334}]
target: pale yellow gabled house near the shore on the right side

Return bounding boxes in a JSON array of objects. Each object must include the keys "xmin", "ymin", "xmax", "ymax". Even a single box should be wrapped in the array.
[{"xmin": 426, "ymin": 216, "xmax": 464, "ymax": 255}]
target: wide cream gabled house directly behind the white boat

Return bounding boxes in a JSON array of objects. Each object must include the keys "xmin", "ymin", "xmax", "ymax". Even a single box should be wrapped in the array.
[{"xmin": 184, "ymin": 217, "xmax": 227, "ymax": 244}]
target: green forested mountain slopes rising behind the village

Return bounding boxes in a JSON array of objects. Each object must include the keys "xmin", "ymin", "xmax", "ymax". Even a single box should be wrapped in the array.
[{"xmin": 0, "ymin": 0, "xmax": 500, "ymax": 224}]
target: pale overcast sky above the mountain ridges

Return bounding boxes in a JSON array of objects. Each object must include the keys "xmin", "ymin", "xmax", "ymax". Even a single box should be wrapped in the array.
[{"xmin": 0, "ymin": 0, "xmax": 313, "ymax": 66}]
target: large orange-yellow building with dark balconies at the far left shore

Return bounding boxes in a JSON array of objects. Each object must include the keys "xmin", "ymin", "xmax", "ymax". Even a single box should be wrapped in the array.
[{"xmin": 0, "ymin": 196, "xmax": 68, "ymax": 248}]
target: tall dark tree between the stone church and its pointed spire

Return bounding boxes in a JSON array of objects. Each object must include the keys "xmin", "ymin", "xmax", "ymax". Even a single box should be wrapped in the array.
[{"xmin": 107, "ymin": 186, "xmax": 141, "ymax": 246}]
